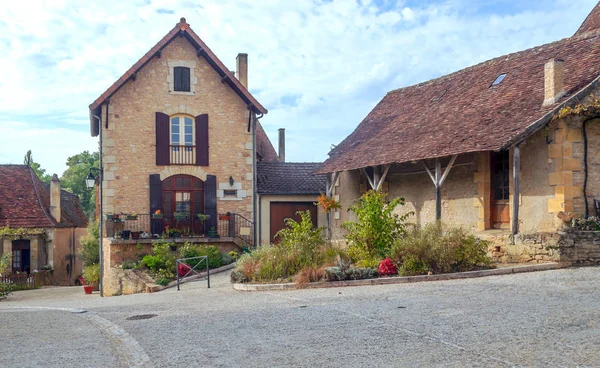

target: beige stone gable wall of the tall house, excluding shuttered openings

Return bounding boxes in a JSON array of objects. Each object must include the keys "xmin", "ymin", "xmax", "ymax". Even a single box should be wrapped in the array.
[{"xmin": 102, "ymin": 37, "xmax": 253, "ymax": 219}]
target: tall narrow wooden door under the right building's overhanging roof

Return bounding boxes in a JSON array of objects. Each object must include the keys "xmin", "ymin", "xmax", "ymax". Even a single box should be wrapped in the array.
[{"xmin": 490, "ymin": 150, "xmax": 510, "ymax": 229}]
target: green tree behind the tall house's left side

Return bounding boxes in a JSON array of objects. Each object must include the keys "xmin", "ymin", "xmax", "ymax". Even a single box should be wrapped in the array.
[{"xmin": 61, "ymin": 151, "xmax": 100, "ymax": 217}]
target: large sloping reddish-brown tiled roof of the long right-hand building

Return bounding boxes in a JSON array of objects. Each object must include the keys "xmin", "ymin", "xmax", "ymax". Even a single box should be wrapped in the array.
[{"xmin": 318, "ymin": 7, "xmax": 600, "ymax": 173}]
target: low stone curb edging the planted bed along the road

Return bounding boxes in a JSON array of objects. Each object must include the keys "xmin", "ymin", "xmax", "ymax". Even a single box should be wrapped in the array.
[{"xmin": 232, "ymin": 262, "xmax": 571, "ymax": 291}]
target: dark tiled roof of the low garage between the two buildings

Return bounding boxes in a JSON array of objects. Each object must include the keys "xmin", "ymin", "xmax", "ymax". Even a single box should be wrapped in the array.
[{"xmin": 256, "ymin": 162, "xmax": 327, "ymax": 194}]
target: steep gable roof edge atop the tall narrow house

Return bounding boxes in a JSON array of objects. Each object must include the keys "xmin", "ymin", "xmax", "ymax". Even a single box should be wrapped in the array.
[{"xmin": 89, "ymin": 18, "xmax": 267, "ymax": 136}]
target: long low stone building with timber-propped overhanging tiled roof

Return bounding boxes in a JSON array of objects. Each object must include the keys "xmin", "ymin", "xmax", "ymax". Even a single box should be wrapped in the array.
[{"xmin": 318, "ymin": 5, "xmax": 600, "ymax": 260}]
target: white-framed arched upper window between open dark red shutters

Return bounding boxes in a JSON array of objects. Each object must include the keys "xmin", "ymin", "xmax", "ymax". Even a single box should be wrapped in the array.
[{"xmin": 169, "ymin": 115, "xmax": 196, "ymax": 165}]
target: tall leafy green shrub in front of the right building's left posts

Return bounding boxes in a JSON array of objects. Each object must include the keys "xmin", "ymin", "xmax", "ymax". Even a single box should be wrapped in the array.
[{"xmin": 342, "ymin": 190, "xmax": 412, "ymax": 264}]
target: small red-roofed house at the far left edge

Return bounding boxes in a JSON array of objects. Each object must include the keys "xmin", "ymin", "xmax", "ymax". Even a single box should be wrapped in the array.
[{"xmin": 0, "ymin": 165, "xmax": 87, "ymax": 285}]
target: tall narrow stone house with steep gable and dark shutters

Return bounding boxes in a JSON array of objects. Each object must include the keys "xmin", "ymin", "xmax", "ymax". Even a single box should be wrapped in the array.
[{"xmin": 89, "ymin": 18, "xmax": 326, "ymax": 295}]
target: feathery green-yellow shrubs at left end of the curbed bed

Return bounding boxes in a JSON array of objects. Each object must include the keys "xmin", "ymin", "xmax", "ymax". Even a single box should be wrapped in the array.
[{"xmin": 231, "ymin": 211, "xmax": 344, "ymax": 282}]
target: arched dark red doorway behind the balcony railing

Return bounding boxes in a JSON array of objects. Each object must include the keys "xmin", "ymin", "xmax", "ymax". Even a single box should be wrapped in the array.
[{"xmin": 162, "ymin": 175, "xmax": 204, "ymax": 235}]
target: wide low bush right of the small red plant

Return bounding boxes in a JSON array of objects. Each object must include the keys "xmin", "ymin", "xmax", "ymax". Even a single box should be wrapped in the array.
[{"xmin": 390, "ymin": 223, "xmax": 492, "ymax": 276}]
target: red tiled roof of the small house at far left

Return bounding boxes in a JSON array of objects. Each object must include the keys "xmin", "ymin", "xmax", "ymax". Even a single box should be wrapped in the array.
[{"xmin": 0, "ymin": 165, "xmax": 87, "ymax": 228}]
